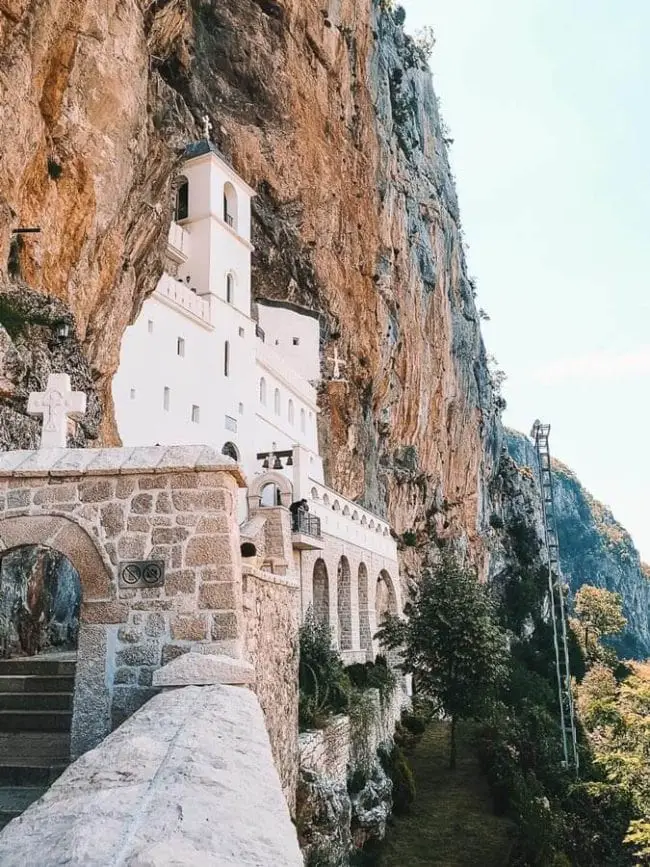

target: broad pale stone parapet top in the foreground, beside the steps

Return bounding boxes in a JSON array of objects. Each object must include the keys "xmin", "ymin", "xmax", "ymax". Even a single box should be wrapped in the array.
[{"xmin": 0, "ymin": 686, "xmax": 303, "ymax": 867}]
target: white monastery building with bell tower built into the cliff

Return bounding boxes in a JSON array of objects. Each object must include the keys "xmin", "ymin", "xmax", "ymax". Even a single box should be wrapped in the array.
[{"xmin": 113, "ymin": 138, "xmax": 402, "ymax": 661}]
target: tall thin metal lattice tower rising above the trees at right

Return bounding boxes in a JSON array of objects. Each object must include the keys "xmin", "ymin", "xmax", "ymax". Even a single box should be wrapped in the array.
[{"xmin": 530, "ymin": 421, "xmax": 579, "ymax": 774}]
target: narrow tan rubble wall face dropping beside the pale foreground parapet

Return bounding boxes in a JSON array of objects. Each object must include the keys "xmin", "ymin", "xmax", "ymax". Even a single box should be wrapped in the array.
[{"xmin": 243, "ymin": 567, "xmax": 300, "ymax": 811}]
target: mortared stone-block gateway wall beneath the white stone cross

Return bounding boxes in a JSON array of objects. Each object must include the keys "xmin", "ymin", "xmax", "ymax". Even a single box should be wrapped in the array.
[{"xmin": 0, "ymin": 446, "xmax": 243, "ymax": 755}]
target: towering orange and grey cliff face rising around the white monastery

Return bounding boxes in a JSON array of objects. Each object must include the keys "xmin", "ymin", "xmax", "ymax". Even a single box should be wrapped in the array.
[{"xmin": 0, "ymin": 0, "xmax": 500, "ymax": 588}]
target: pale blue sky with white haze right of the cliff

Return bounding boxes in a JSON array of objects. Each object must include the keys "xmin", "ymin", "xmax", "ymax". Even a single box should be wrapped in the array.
[{"xmin": 402, "ymin": 0, "xmax": 650, "ymax": 561}]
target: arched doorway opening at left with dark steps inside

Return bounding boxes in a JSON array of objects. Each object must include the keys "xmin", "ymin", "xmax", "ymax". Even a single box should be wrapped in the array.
[{"xmin": 0, "ymin": 544, "xmax": 81, "ymax": 828}]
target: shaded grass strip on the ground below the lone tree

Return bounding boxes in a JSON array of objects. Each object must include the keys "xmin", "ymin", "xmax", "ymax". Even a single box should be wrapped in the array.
[{"xmin": 379, "ymin": 722, "xmax": 511, "ymax": 867}]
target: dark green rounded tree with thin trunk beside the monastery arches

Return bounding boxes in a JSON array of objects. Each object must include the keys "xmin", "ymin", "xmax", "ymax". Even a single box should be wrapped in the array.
[{"xmin": 377, "ymin": 555, "xmax": 508, "ymax": 768}]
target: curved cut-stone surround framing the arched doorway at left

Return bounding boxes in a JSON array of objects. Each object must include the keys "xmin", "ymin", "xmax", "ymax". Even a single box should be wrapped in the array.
[{"xmin": 0, "ymin": 515, "xmax": 114, "ymax": 757}]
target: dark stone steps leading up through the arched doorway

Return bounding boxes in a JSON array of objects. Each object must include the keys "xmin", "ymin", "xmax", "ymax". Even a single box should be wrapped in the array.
[{"xmin": 0, "ymin": 653, "xmax": 76, "ymax": 828}]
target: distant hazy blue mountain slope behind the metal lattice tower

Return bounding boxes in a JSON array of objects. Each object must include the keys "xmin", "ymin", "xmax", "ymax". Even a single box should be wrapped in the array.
[{"xmin": 506, "ymin": 431, "xmax": 650, "ymax": 659}]
